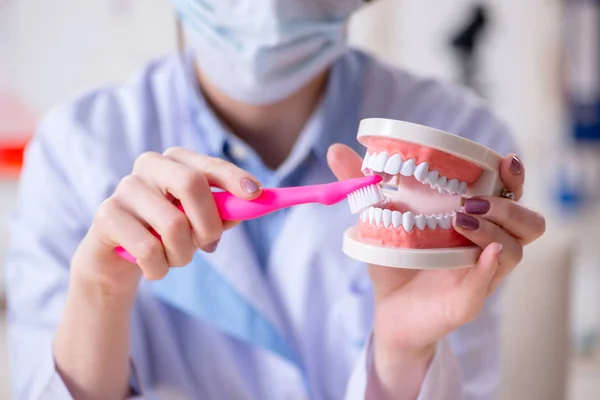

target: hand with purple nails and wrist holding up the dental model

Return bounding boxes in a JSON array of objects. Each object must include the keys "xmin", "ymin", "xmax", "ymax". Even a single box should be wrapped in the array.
[{"xmin": 328, "ymin": 145, "xmax": 545, "ymax": 399}]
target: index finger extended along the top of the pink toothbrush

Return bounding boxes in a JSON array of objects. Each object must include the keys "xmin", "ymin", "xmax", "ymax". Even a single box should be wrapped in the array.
[{"xmin": 164, "ymin": 147, "xmax": 262, "ymax": 200}]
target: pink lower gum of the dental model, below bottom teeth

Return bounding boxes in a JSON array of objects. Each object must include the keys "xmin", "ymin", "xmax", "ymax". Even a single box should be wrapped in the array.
[{"xmin": 358, "ymin": 220, "xmax": 473, "ymax": 249}]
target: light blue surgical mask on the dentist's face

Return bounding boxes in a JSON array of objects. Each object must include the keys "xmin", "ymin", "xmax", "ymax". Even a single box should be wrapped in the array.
[{"xmin": 172, "ymin": 0, "xmax": 362, "ymax": 104}]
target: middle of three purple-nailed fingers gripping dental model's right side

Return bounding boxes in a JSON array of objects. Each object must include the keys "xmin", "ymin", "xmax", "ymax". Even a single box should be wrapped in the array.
[{"xmin": 464, "ymin": 197, "xmax": 546, "ymax": 245}]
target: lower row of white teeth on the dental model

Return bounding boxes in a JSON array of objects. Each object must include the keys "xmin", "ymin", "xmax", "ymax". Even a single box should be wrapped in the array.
[{"xmin": 360, "ymin": 207, "xmax": 454, "ymax": 232}]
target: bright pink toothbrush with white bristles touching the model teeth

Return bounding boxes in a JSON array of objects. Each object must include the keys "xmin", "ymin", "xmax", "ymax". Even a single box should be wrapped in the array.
[{"xmin": 115, "ymin": 175, "xmax": 385, "ymax": 263}]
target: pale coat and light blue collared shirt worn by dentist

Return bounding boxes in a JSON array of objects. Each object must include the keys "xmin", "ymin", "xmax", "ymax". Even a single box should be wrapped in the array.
[{"xmin": 6, "ymin": 51, "xmax": 515, "ymax": 400}]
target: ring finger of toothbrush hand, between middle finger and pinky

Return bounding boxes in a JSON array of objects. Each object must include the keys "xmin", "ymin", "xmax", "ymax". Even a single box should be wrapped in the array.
[{"xmin": 115, "ymin": 175, "xmax": 196, "ymax": 267}]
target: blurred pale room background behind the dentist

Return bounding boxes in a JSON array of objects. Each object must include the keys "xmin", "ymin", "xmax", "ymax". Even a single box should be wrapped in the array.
[{"xmin": 0, "ymin": 0, "xmax": 600, "ymax": 400}]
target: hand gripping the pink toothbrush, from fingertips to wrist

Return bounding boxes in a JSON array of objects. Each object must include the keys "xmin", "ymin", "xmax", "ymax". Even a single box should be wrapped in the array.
[{"xmin": 71, "ymin": 148, "xmax": 261, "ymax": 294}]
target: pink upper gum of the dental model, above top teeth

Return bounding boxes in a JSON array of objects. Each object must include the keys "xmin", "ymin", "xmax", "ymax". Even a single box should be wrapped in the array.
[{"xmin": 367, "ymin": 137, "xmax": 483, "ymax": 183}]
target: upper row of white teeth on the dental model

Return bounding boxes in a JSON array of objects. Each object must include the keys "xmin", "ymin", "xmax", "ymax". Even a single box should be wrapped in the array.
[{"xmin": 362, "ymin": 151, "xmax": 467, "ymax": 195}]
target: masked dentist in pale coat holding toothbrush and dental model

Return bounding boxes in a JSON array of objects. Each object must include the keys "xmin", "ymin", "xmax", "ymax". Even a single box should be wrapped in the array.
[{"xmin": 7, "ymin": 0, "xmax": 544, "ymax": 400}]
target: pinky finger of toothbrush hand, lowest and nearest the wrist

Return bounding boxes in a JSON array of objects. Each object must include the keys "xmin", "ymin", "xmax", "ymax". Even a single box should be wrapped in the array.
[{"xmin": 94, "ymin": 198, "xmax": 169, "ymax": 280}]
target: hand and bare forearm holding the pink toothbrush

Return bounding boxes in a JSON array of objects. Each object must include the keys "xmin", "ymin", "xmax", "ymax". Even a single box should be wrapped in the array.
[{"xmin": 54, "ymin": 148, "xmax": 261, "ymax": 399}]
